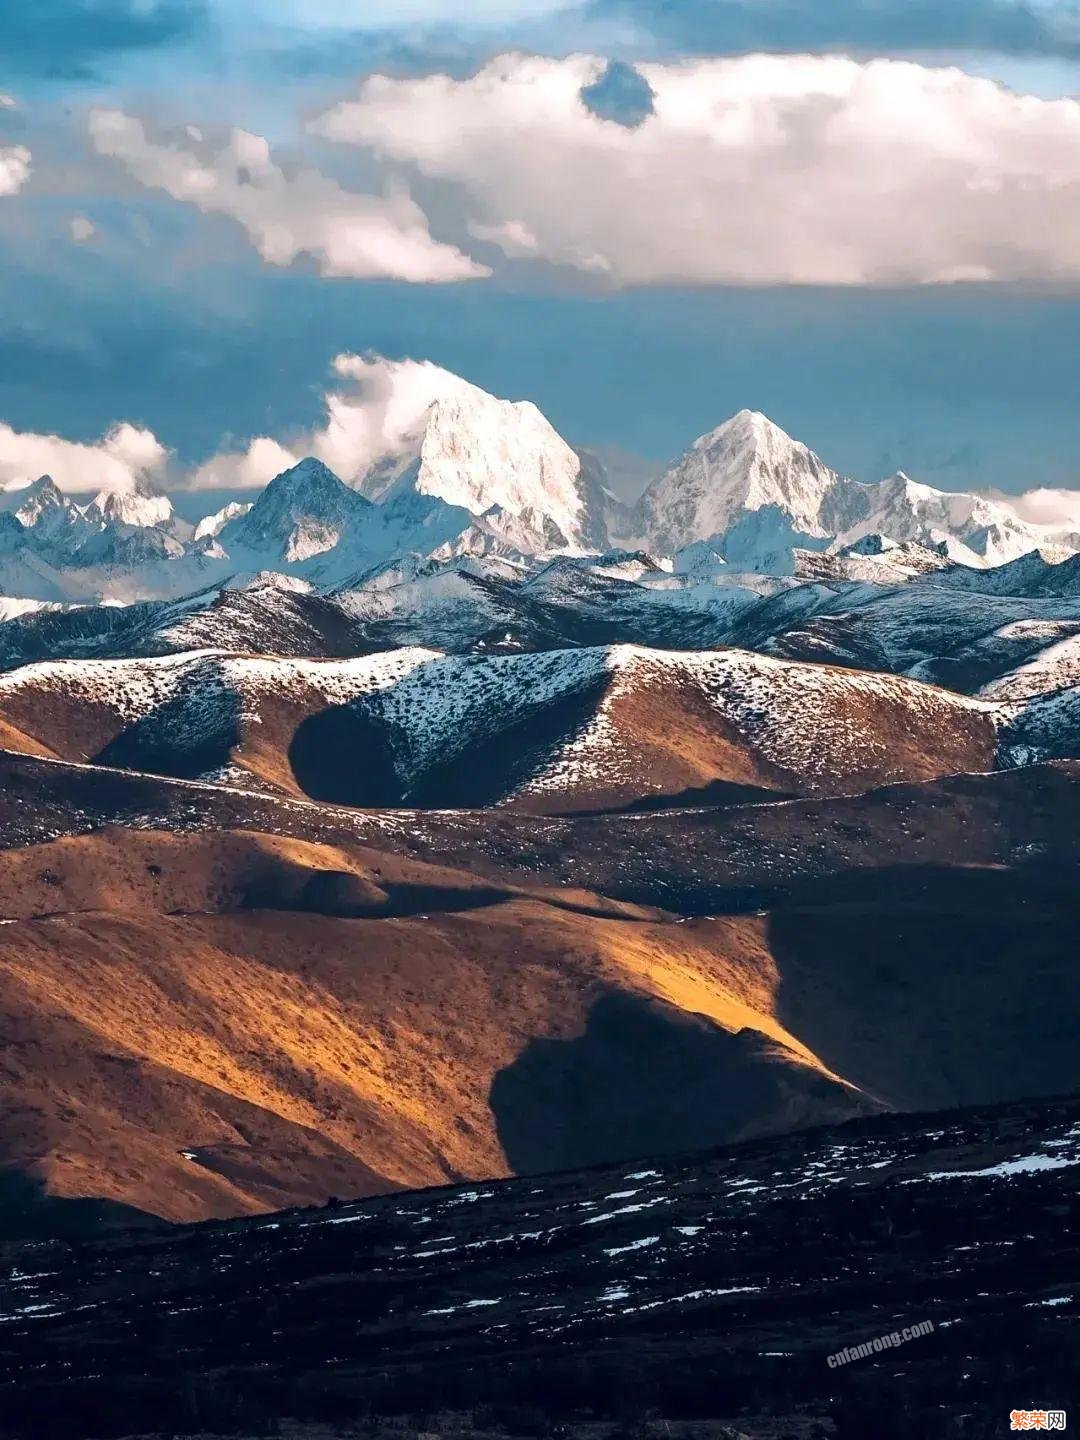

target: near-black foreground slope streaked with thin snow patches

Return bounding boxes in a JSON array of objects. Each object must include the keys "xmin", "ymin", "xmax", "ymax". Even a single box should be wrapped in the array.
[{"xmin": 0, "ymin": 1097, "xmax": 1080, "ymax": 1440}]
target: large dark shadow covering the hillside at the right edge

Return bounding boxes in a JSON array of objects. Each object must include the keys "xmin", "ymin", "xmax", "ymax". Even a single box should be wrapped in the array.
[{"xmin": 769, "ymin": 865, "xmax": 1080, "ymax": 1110}]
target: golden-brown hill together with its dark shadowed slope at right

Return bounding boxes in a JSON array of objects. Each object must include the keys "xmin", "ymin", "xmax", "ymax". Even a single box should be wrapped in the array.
[{"xmin": 0, "ymin": 828, "xmax": 1077, "ymax": 1224}]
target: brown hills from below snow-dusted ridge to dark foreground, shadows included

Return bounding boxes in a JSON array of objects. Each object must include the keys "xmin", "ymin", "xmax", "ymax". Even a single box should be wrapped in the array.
[{"xmin": 0, "ymin": 757, "xmax": 1077, "ymax": 1233}]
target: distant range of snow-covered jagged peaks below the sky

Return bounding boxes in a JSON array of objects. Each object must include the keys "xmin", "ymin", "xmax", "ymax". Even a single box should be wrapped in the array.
[{"xmin": 0, "ymin": 380, "xmax": 1080, "ymax": 602}]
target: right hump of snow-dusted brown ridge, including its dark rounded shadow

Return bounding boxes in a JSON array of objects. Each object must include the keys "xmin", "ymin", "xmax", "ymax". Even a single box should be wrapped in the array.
[{"xmin": 289, "ymin": 648, "xmax": 998, "ymax": 815}]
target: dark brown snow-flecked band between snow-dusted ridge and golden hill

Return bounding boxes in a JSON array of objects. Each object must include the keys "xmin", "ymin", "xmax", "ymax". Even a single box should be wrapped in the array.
[{"xmin": 0, "ymin": 752, "xmax": 1080, "ymax": 914}]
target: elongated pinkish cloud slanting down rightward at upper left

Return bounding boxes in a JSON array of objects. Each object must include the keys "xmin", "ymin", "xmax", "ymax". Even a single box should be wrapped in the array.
[{"xmin": 89, "ymin": 109, "xmax": 488, "ymax": 284}]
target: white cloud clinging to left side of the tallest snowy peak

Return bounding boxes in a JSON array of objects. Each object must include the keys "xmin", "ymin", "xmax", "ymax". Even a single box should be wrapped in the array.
[{"xmin": 190, "ymin": 353, "xmax": 472, "ymax": 498}]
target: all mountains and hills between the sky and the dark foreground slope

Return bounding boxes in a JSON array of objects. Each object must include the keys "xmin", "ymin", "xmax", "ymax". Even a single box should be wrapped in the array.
[{"xmin": 0, "ymin": 362, "xmax": 1080, "ymax": 1347}]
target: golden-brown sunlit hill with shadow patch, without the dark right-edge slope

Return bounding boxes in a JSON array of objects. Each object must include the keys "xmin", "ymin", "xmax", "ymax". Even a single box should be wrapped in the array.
[{"xmin": 0, "ymin": 829, "xmax": 871, "ymax": 1220}]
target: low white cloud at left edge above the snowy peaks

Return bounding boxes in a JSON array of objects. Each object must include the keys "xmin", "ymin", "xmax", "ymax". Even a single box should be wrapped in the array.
[{"xmin": 0, "ymin": 423, "xmax": 168, "ymax": 491}]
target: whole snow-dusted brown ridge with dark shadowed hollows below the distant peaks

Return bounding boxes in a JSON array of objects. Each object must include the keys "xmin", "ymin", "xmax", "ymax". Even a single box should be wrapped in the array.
[{"xmin": 0, "ymin": 647, "xmax": 996, "ymax": 812}]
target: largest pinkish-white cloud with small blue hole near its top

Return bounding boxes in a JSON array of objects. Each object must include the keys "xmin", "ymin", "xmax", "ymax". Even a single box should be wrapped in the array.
[{"xmin": 312, "ymin": 55, "xmax": 1080, "ymax": 285}]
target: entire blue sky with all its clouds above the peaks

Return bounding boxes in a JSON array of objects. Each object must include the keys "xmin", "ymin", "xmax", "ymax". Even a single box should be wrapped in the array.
[{"xmin": 0, "ymin": 0, "xmax": 1080, "ymax": 513}]
